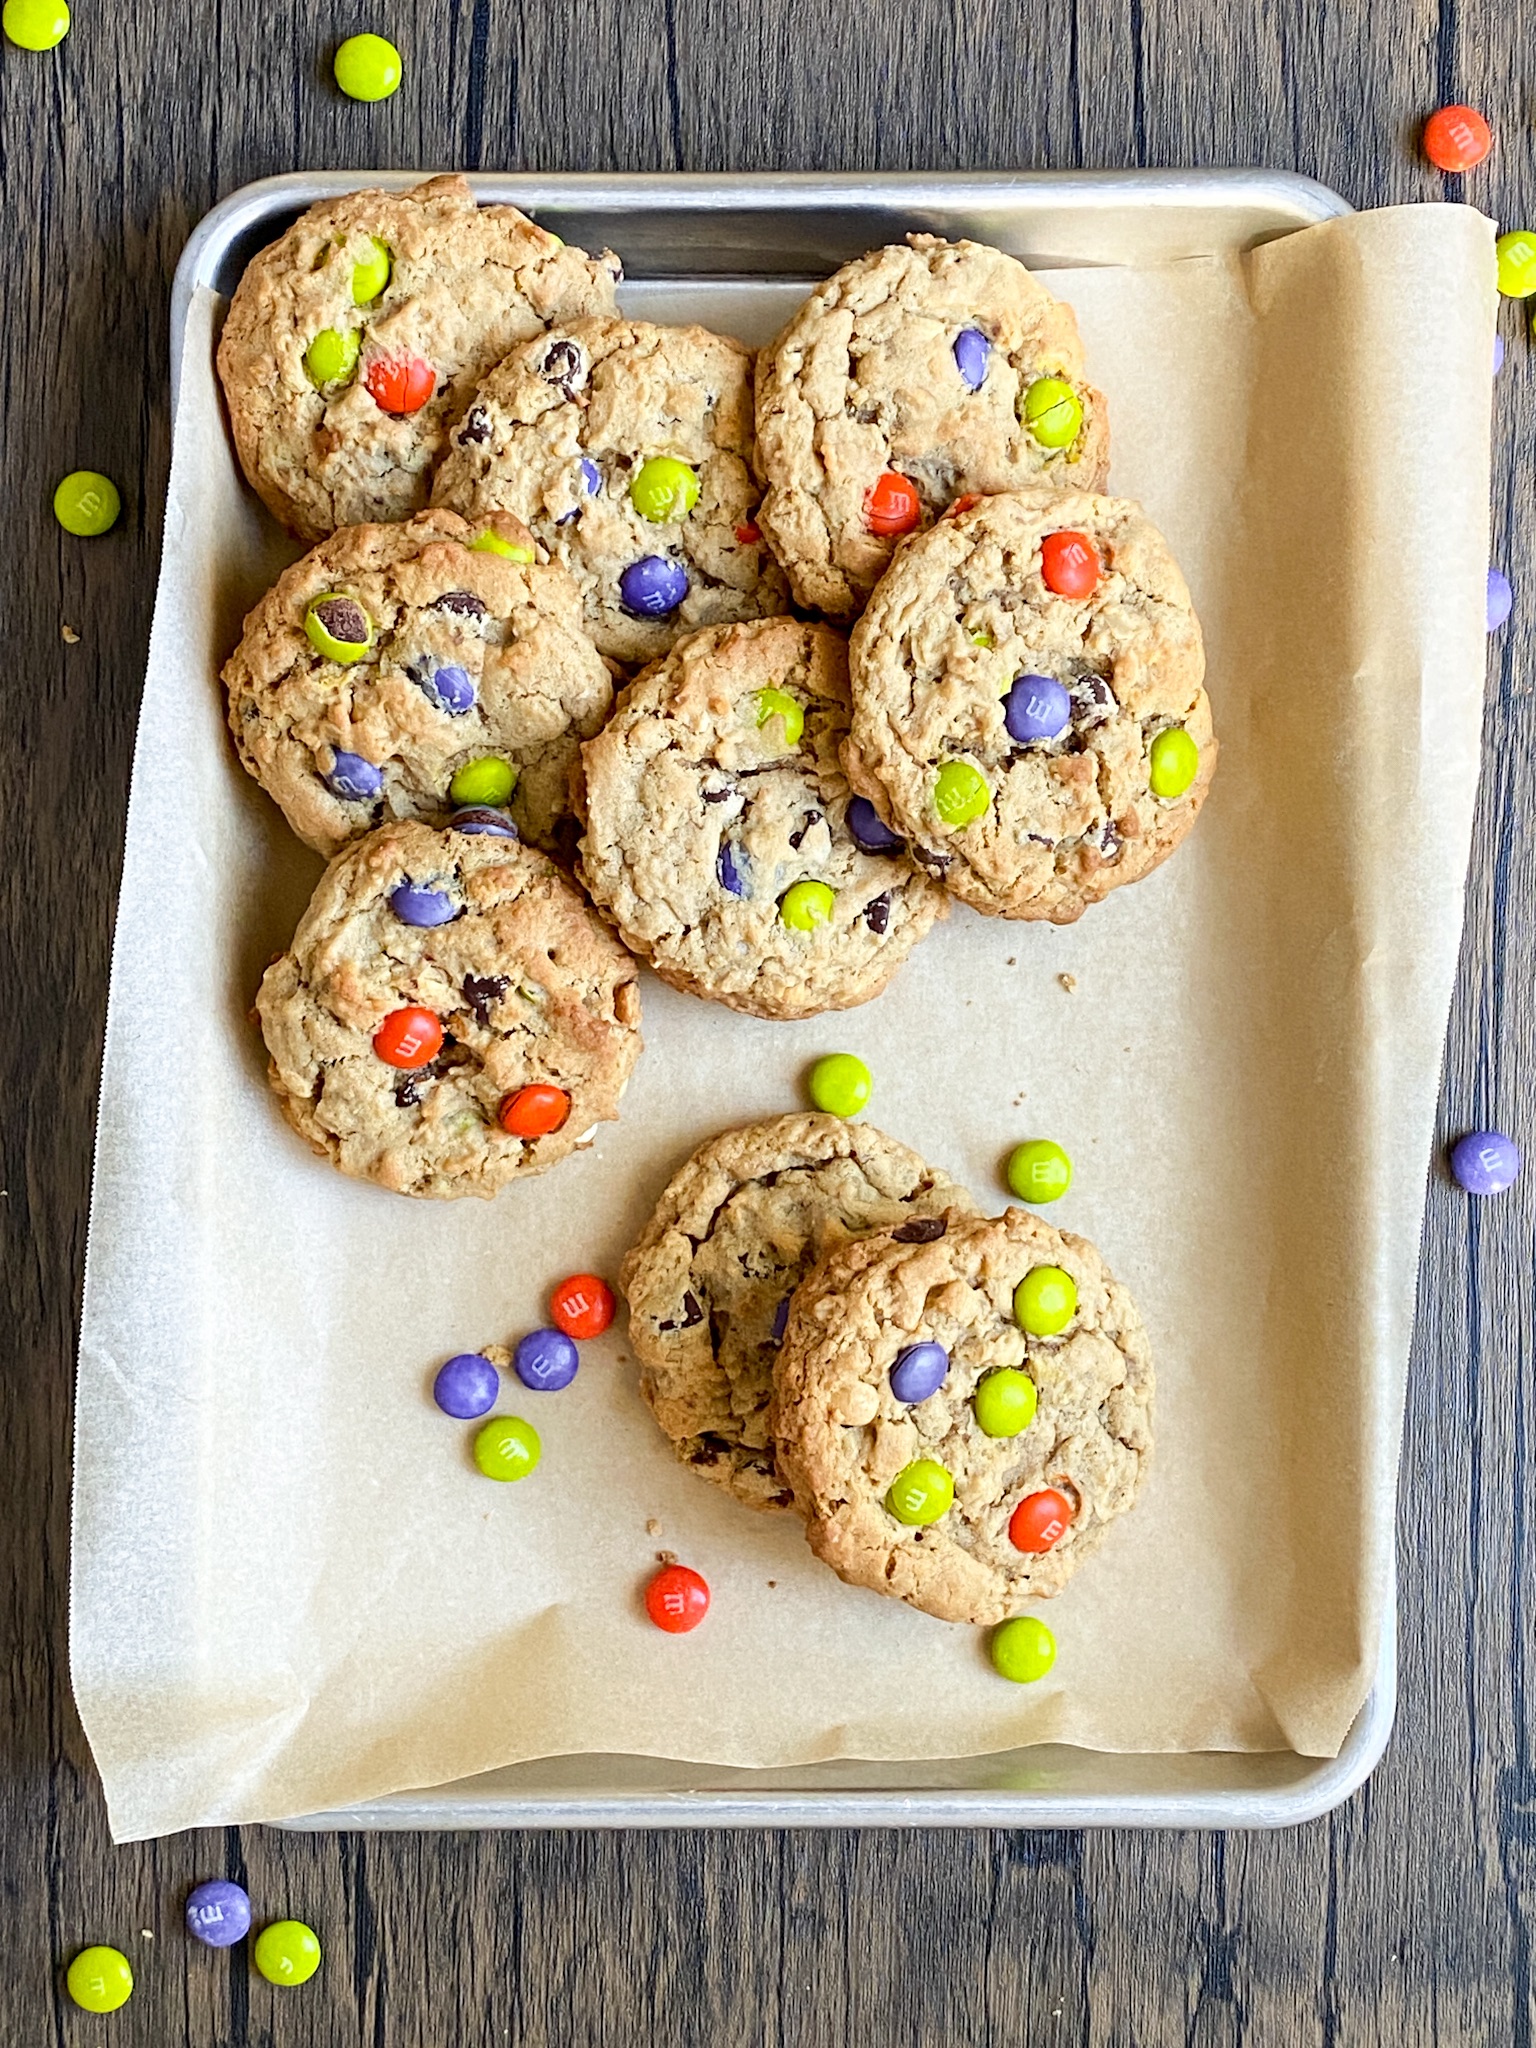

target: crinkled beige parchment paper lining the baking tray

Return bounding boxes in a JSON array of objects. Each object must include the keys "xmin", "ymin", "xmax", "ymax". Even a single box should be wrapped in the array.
[{"xmin": 72, "ymin": 207, "xmax": 1495, "ymax": 1839}]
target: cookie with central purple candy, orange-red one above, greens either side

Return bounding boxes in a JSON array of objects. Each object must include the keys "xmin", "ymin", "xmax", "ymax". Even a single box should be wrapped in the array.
[{"xmin": 844, "ymin": 487, "xmax": 1217, "ymax": 924}]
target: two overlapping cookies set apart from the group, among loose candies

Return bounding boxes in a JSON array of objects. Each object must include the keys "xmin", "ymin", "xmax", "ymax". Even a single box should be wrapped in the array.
[{"xmin": 621, "ymin": 1114, "xmax": 1153, "ymax": 1624}]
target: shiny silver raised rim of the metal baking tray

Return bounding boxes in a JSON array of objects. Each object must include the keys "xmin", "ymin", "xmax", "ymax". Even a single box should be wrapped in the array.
[{"xmin": 159, "ymin": 166, "xmax": 1397, "ymax": 1833}]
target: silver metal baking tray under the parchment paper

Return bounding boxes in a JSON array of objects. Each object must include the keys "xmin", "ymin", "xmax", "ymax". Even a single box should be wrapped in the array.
[{"xmin": 172, "ymin": 170, "xmax": 1397, "ymax": 1829}]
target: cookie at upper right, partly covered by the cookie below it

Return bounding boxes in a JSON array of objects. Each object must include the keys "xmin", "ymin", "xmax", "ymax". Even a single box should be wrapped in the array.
[{"xmin": 758, "ymin": 236, "xmax": 1108, "ymax": 618}]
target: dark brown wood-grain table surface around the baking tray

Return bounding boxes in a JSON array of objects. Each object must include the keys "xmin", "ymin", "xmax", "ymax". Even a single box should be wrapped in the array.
[{"xmin": 0, "ymin": 0, "xmax": 1536, "ymax": 2048}]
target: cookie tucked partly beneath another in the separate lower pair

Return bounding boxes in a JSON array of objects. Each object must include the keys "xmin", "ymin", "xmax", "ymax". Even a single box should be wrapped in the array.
[{"xmin": 618, "ymin": 1114, "xmax": 973, "ymax": 1507}]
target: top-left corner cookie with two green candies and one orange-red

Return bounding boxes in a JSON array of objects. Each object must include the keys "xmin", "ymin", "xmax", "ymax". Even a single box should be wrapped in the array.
[{"xmin": 219, "ymin": 178, "xmax": 618, "ymax": 541}]
